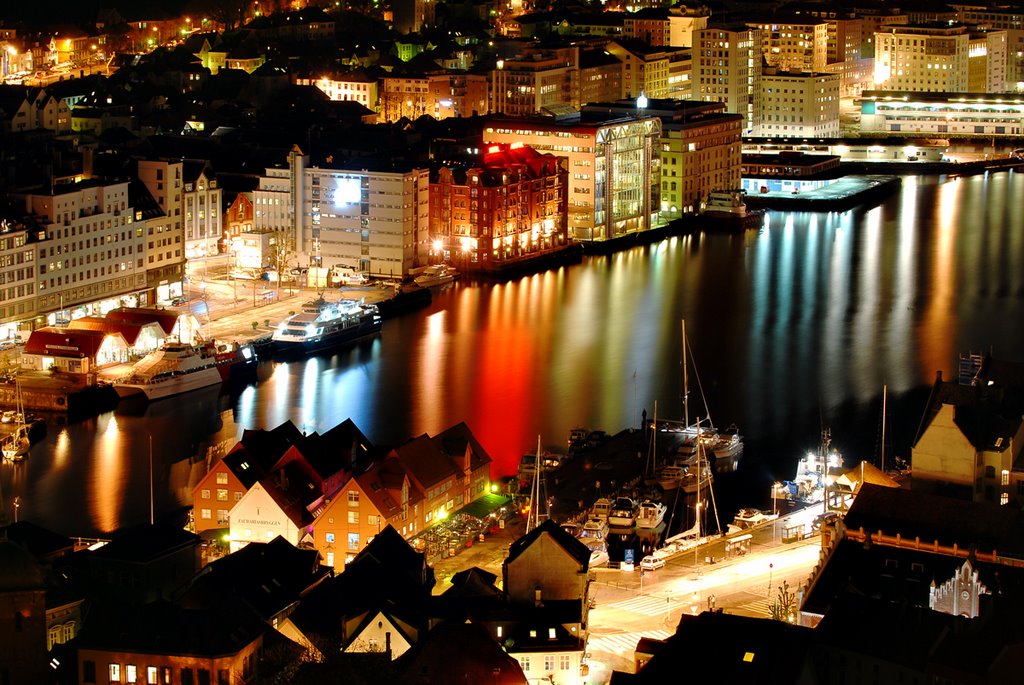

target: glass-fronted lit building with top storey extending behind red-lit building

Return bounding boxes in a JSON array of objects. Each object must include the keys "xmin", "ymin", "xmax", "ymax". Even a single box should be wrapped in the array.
[{"xmin": 483, "ymin": 108, "xmax": 662, "ymax": 242}]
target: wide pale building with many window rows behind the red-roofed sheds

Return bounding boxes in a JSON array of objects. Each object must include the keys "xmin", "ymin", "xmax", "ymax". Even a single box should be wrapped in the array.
[{"xmin": 22, "ymin": 179, "xmax": 150, "ymax": 326}]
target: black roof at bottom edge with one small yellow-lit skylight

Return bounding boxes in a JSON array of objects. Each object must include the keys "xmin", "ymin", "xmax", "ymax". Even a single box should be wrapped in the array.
[{"xmin": 614, "ymin": 611, "xmax": 812, "ymax": 685}]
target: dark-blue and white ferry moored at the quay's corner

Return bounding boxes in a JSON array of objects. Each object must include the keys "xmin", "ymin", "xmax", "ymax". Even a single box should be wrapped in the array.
[{"xmin": 271, "ymin": 297, "xmax": 381, "ymax": 355}]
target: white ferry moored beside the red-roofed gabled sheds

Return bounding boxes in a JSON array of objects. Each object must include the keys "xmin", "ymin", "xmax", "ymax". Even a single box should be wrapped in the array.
[{"xmin": 114, "ymin": 342, "xmax": 256, "ymax": 400}]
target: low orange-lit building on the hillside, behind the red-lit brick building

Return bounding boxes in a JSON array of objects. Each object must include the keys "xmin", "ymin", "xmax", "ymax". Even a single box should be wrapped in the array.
[{"xmin": 374, "ymin": 72, "xmax": 490, "ymax": 122}]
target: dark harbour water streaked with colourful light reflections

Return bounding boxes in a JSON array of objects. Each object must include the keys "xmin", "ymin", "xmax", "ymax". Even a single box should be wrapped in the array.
[{"xmin": 6, "ymin": 173, "xmax": 1024, "ymax": 534}]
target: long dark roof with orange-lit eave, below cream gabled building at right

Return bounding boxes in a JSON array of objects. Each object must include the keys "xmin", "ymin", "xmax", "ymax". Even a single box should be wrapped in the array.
[{"xmin": 844, "ymin": 483, "xmax": 1024, "ymax": 558}]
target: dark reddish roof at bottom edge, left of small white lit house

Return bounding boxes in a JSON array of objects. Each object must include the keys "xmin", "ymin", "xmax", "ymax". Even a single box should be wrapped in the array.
[{"xmin": 387, "ymin": 622, "xmax": 527, "ymax": 685}]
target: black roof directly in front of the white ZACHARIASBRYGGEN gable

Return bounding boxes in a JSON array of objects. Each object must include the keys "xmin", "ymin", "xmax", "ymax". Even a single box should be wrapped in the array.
[{"xmin": 179, "ymin": 536, "xmax": 330, "ymax": 620}]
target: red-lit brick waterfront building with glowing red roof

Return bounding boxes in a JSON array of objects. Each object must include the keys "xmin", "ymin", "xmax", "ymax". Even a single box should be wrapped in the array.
[{"xmin": 430, "ymin": 143, "xmax": 568, "ymax": 270}]
